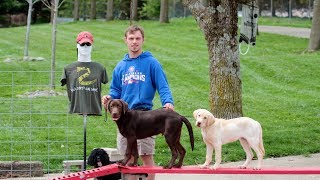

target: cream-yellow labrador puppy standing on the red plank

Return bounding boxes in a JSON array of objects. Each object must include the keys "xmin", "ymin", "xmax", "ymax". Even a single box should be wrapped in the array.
[{"xmin": 193, "ymin": 109, "xmax": 265, "ymax": 169}]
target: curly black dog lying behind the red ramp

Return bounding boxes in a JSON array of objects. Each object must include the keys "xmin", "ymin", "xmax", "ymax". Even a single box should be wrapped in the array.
[{"xmin": 88, "ymin": 148, "xmax": 121, "ymax": 180}]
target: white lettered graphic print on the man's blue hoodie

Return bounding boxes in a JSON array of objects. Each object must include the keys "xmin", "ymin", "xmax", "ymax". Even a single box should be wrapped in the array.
[{"xmin": 122, "ymin": 66, "xmax": 146, "ymax": 85}]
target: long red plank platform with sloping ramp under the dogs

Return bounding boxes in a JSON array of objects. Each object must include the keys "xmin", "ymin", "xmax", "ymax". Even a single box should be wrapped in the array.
[{"xmin": 51, "ymin": 164, "xmax": 320, "ymax": 180}]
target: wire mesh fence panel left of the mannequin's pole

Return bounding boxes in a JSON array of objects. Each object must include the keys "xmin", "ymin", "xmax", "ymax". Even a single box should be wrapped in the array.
[{"xmin": 0, "ymin": 71, "xmax": 84, "ymax": 179}]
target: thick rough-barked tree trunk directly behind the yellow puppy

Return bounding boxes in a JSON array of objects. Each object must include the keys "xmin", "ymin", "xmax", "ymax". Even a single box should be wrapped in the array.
[{"xmin": 183, "ymin": 0, "xmax": 252, "ymax": 119}]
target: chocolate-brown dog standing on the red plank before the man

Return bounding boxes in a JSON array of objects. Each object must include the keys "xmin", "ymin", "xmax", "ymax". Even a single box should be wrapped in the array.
[{"xmin": 106, "ymin": 99, "xmax": 194, "ymax": 169}]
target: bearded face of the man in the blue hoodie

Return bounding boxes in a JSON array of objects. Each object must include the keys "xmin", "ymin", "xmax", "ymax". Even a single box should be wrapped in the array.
[{"xmin": 125, "ymin": 31, "xmax": 144, "ymax": 53}]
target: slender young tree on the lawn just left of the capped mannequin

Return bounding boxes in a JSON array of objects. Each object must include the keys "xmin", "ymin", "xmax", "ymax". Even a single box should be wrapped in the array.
[{"xmin": 41, "ymin": 0, "xmax": 65, "ymax": 89}]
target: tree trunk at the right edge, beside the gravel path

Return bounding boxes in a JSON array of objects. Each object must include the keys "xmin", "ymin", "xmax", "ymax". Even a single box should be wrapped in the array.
[{"xmin": 308, "ymin": 0, "xmax": 320, "ymax": 51}]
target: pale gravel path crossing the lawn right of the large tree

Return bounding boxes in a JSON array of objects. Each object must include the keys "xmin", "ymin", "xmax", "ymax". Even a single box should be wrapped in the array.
[{"xmin": 258, "ymin": 26, "xmax": 311, "ymax": 38}]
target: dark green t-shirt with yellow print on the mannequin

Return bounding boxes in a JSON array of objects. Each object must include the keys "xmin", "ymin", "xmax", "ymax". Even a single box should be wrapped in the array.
[{"xmin": 61, "ymin": 61, "xmax": 108, "ymax": 115}]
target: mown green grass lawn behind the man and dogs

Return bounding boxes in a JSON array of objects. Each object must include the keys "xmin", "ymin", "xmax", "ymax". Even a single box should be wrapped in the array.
[{"xmin": 0, "ymin": 18, "xmax": 320, "ymax": 171}]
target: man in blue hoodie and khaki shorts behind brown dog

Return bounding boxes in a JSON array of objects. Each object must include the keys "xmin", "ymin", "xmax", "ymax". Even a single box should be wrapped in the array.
[{"xmin": 102, "ymin": 25, "xmax": 174, "ymax": 180}]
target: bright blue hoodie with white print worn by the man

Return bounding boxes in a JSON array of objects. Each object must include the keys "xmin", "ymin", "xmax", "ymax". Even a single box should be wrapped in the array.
[{"xmin": 109, "ymin": 52, "xmax": 173, "ymax": 110}]
